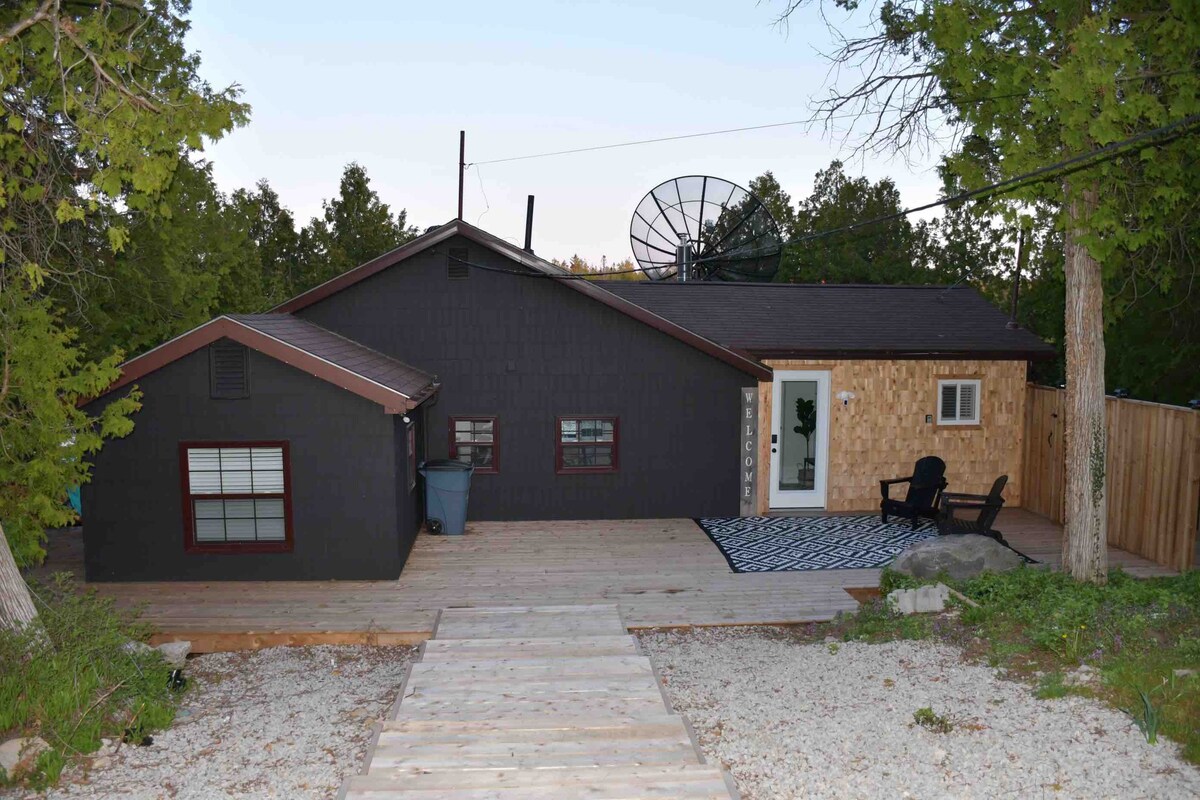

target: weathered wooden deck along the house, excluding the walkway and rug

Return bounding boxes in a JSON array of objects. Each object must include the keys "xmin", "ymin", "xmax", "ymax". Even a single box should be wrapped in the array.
[{"xmin": 40, "ymin": 509, "xmax": 1171, "ymax": 651}]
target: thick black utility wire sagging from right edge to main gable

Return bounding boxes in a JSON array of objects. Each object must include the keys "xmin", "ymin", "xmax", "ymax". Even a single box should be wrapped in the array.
[{"xmin": 450, "ymin": 114, "xmax": 1200, "ymax": 281}]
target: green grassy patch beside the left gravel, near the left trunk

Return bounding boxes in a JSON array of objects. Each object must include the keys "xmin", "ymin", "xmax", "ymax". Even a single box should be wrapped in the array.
[{"xmin": 0, "ymin": 576, "xmax": 176, "ymax": 788}]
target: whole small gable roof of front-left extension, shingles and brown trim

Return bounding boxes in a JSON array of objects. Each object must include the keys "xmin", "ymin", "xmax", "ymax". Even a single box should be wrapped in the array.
[{"xmin": 85, "ymin": 314, "xmax": 438, "ymax": 414}]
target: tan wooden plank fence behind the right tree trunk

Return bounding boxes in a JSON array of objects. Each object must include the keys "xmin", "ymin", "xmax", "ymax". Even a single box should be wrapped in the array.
[{"xmin": 1021, "ymin": 385, "xmax": 1200, "ymax": 571}]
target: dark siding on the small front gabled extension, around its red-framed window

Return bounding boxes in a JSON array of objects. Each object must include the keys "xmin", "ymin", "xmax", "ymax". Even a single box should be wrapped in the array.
[{"xmin": 83, "ymin": 348, "xmax": 412, "ymax": 581}]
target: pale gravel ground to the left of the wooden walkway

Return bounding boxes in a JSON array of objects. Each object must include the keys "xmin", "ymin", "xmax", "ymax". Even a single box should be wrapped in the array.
[{"xmin": 10, "ymin": 646, "xmax": 415, "ymax": 800}]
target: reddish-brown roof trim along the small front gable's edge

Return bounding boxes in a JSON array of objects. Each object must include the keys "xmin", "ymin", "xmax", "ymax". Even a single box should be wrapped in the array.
[{"xmin": 80, "ymin": 317, "xmax": 437, "ymax": 414}]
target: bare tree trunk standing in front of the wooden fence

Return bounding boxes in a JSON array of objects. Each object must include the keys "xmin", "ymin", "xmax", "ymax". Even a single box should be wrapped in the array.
[{"xmin": 1062, "ymin": 184, "xmax": 1109, "ymax": 584}]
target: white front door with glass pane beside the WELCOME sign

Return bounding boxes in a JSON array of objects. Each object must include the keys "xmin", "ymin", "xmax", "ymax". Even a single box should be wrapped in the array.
[{"xmin": 770, "ymin": 369, "xmax": 829, "ymax": 509}]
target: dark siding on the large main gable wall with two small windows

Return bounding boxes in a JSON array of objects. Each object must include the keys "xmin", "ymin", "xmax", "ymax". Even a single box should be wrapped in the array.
[{"xmin": 299, "ymin": 237, "xmax": 756, "ymax": 519}]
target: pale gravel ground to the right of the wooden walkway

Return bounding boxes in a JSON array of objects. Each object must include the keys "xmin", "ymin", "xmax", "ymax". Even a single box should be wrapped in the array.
[{"xmin": 642, "ymin": 628, "xmax": 1200, "ymax": 800}]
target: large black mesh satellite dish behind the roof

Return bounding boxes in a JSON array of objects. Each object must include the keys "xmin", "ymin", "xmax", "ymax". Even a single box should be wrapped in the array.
[{"xmin": 629, "ymin": 175, "xmax": 782, "ymax": 281}]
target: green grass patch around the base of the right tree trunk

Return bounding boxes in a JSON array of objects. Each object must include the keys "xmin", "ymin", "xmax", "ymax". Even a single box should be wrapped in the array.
[{"xmin": 835, "ymin": 567, "xmax": 1200, "ymax": 764}]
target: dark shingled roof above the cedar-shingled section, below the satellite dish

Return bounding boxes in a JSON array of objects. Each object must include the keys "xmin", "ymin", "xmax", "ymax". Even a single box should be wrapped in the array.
[{"xmin": 600, "ymin": 281, "xmax": 1055, "ymax": 360}]
